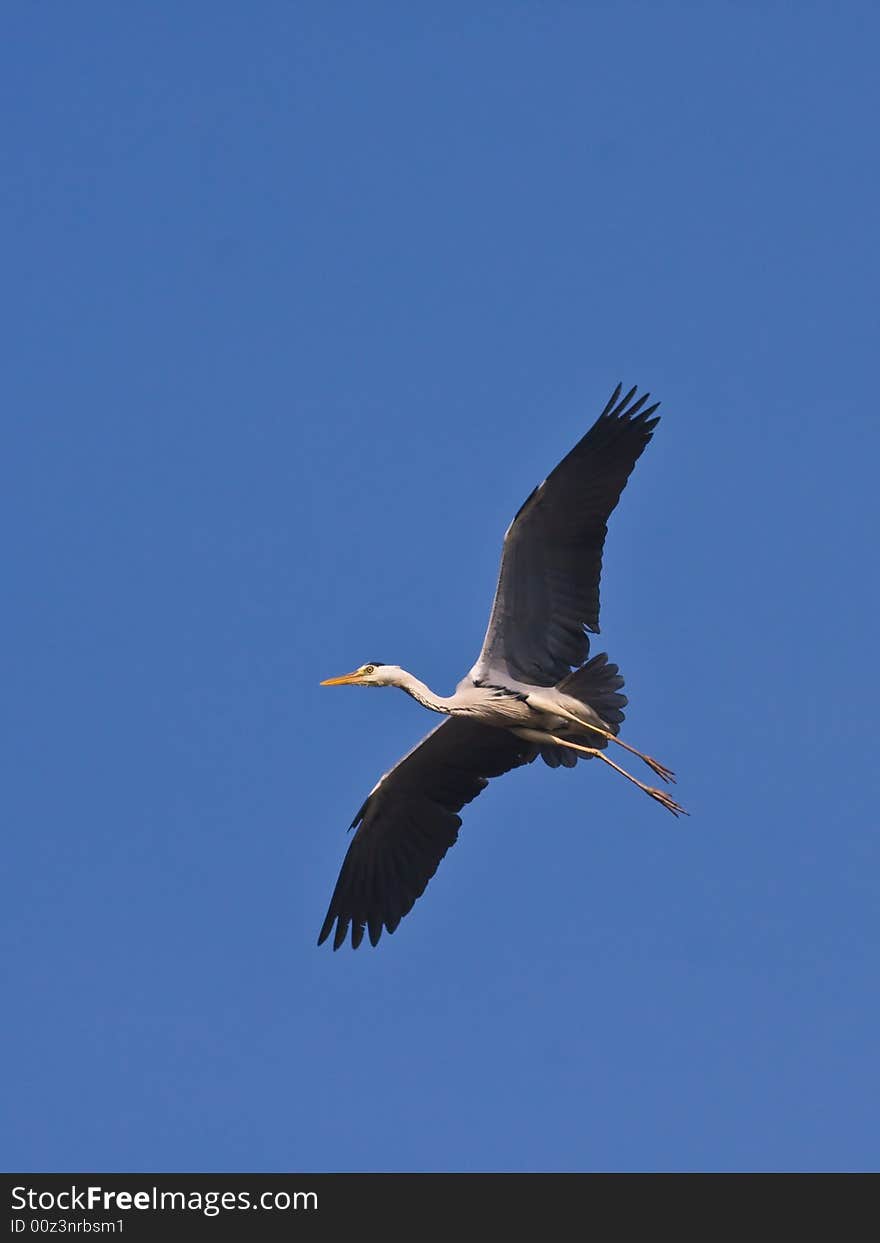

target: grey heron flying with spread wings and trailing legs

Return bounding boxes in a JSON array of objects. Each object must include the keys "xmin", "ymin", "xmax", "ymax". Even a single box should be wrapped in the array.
[{"xmin": 318, "ymin": 384, "xmax": 686, "ymax": 950}]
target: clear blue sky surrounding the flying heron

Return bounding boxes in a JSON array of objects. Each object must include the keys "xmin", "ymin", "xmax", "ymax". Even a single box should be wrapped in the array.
[{"xmin": 0, "ymin": 0, "xmax": 880, "ymax": 1171}]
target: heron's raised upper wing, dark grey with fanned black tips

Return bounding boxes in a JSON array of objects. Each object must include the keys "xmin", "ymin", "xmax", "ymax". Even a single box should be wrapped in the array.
[{"xmin": 470, "ymin": 384, "xmax": 660, "ymax": 686}]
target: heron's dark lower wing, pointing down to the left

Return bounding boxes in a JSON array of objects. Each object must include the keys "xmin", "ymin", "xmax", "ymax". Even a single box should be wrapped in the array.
[{"xmin": 318, "ymin": 717, "xmax": 537, "ymax": 950}]
